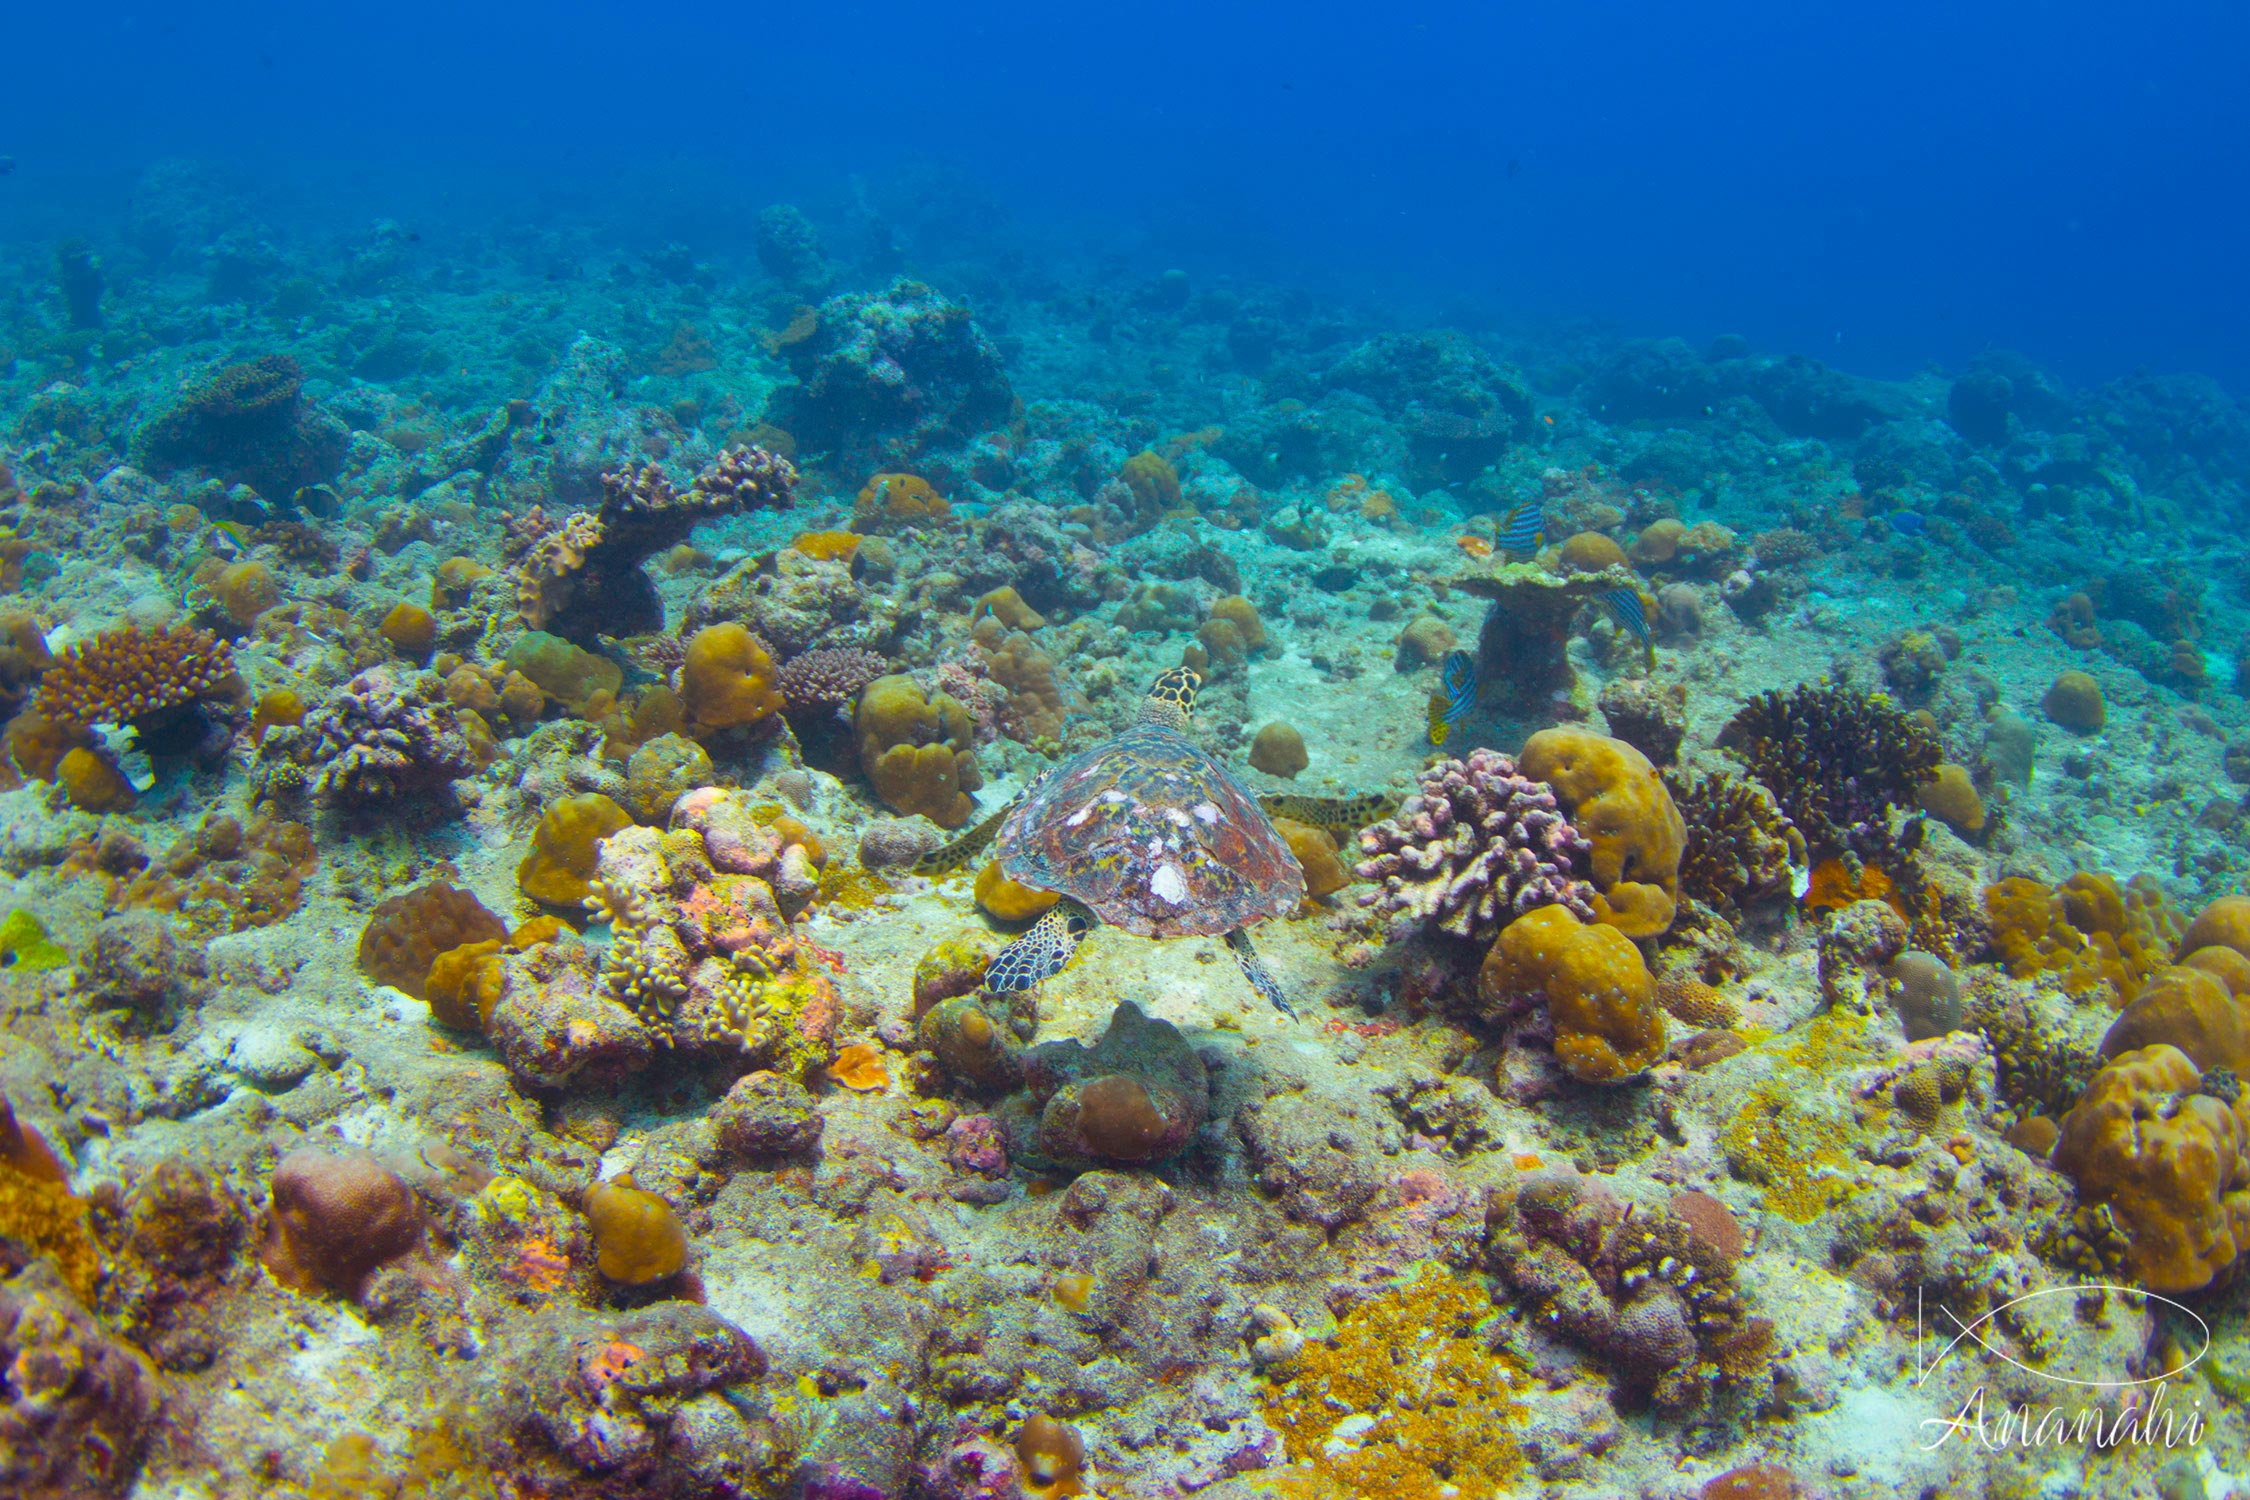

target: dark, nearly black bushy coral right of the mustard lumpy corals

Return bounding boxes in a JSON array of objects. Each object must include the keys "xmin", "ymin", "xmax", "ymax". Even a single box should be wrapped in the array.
[{"xmin": 1719, "ymin": 684, "xmax": 1940, "ymax": 875}]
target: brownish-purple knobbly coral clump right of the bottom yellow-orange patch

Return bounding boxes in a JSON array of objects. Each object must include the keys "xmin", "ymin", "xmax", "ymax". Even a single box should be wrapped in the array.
[{"xmin": 1485, "ymin": 1174, "xmax": 1773, "ymax": 1412}]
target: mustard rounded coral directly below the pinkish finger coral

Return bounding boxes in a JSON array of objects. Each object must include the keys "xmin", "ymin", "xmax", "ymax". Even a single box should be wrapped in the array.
[{"xmin": 1476, "ymin": 906, "xmax": 1665, "ymax": 1084}]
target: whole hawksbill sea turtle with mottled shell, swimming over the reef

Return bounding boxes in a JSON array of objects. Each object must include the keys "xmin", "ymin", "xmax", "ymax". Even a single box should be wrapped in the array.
[{"xmin": 916, "ymin": 666, "xmax": 1373, "ymax": 1019}]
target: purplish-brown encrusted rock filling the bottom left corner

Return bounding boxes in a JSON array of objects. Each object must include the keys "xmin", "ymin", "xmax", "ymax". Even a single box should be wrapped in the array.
[{"xmin": 0, "ymin": 1262, "xmax": 162, "ymax": 1500}]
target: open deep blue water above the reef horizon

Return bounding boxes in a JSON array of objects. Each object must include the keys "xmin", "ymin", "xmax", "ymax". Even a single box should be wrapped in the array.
[{"xmin": 0, "ymin": 0, "xmax": 2250, "ymax": 389}]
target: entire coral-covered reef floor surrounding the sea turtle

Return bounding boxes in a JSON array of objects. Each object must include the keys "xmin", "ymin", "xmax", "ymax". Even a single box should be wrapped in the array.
[{"xmin": 0, "ymin": 202, "xmax": 2250, "ymax": 1500}]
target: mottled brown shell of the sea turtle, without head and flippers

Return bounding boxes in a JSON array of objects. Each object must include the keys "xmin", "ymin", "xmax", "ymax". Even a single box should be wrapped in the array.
[{"xmin": 999, "ymin": 724, "xmax": 1305, "ymax": 938}]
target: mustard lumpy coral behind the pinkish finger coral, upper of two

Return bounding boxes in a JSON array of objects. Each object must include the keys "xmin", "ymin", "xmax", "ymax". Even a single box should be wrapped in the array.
[{"xmin": 1521, "ymin": 729, "xmax": 1688, "ymax": 938}]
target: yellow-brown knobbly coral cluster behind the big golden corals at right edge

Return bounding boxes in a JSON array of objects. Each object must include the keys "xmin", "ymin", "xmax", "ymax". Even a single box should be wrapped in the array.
[{"xmin": 1985, "ymin": 870, "xmax": 2180, "ymax": 1007}]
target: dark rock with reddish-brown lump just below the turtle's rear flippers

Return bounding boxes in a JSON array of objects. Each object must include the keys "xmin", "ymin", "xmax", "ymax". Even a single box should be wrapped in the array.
[{"xmin": 1030, "ymin": 1001, "xmax": 1211, "ymax": 1165}]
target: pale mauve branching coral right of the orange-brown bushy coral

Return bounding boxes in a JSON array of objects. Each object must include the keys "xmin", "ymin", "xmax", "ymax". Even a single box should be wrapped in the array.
[{"xmin": 274, "ymin": 668, "xmax": 479, "ymax": 814}]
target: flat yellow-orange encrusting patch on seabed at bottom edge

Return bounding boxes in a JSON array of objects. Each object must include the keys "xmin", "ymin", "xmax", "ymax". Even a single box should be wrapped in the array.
[{"xmin": 1262, "ymin": 1271, "xmax": 1528, "ymax": 1500}]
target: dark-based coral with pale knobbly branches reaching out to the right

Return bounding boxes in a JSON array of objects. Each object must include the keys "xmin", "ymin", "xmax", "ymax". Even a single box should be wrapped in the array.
[{"xmin": 515, "ymin": 445, "xmax": 797, "ymax": 639}]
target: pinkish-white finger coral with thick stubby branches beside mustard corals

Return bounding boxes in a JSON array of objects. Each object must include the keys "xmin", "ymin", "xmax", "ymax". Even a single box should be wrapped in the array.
[{"xmin": 1357, "ymin": 749, "xmax": 1593, "ymax": 942}]
